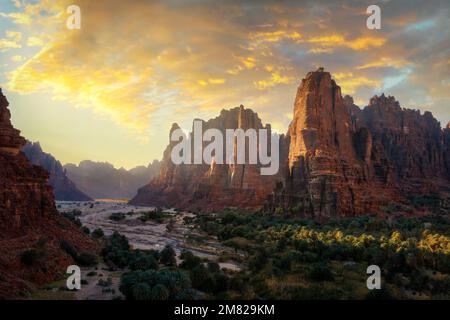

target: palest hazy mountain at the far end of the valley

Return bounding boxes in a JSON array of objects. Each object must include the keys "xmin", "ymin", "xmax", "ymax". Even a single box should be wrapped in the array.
[{"xmin": 64, "ymin": 160, "xmax": 160, "ymax": 199}]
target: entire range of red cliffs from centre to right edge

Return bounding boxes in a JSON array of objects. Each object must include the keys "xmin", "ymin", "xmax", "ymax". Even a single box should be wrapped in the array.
[{"xmin": 132, "ymin": 68, "xmax": 450, "ymax": 219}]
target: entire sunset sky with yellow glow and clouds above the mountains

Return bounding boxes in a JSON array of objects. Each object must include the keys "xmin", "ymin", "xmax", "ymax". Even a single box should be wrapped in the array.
[{"xmin": 0, "ymin": 0, "xmax": 450, "ymax": 168}]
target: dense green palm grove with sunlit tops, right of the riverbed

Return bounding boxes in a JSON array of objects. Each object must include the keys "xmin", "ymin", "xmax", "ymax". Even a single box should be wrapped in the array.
[{"xmin": 192, "ymin": 208, "xmax": 450, "ymax": 299}]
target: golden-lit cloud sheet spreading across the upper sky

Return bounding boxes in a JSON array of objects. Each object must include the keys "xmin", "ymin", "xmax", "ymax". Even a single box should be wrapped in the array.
[{"xmin": 0, "ymin": 0, "xmax": 450, "ymax": 141}]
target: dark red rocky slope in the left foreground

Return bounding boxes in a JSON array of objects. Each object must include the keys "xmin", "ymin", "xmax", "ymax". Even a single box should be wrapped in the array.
[{"xmin": 0, "ymin": 90, "xmax": 96, "ymax": 298}]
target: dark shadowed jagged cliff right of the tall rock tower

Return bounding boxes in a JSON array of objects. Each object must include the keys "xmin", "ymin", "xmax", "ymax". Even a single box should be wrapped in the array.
[{"xmin": 358, "ymin": 94, "xmax": 447, "ymax": 188}]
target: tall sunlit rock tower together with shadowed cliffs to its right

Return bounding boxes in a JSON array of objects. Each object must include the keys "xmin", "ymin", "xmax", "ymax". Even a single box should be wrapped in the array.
[{"xmin": 266, "ymin": 69, "xmax": 450, "ymax": 219}]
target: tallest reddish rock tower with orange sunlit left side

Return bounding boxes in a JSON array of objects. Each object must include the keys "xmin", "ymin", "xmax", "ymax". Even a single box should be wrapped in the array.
[{"xmin": 269, "ymin": 70, "xmax": 380, "ymax": 219}]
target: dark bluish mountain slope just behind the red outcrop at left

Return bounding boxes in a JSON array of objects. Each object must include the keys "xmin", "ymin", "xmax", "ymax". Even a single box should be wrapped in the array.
[{"xmin": 22, "ymin": 141, "xmax": 92, "ymax": 201}]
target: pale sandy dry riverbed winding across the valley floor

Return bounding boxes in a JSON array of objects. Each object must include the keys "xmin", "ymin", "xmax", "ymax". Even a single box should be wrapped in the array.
[{"xmin": 57, "ymin": 199, "xmax": 240, "ymax": 300}]
